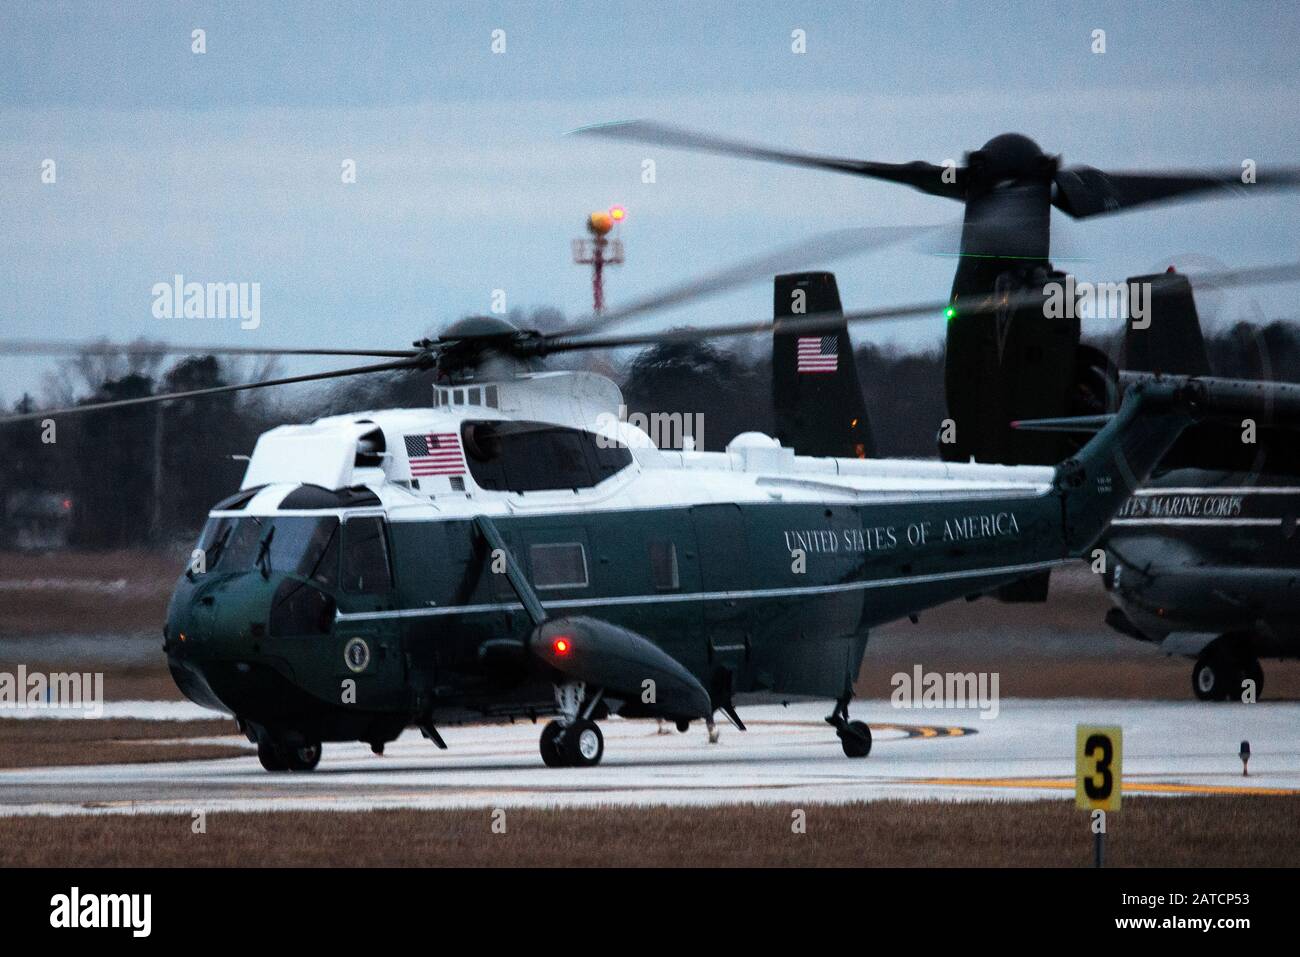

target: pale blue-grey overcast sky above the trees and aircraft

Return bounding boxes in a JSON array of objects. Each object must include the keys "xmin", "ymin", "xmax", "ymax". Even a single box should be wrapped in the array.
[{"xmin": 0, "ymin": 0, "xmax": 1300, "ymax": 404}]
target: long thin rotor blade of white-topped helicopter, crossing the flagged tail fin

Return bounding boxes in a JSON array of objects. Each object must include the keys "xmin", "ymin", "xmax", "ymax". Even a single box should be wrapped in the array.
[{"xmin": 545, "ymin": 261, "xmax": 1300, "ymax": 352}]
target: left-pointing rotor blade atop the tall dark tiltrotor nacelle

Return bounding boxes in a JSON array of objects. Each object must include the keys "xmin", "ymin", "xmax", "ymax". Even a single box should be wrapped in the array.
[{"xmin": 571, "ymin": 120, "xmax": 965, "ymax": 199}]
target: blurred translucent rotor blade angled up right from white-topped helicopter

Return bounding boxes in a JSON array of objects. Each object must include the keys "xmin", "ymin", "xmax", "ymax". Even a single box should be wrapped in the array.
[{"xmin": 547, "ymin": 226, "xmax": 946, "ymax": 339}]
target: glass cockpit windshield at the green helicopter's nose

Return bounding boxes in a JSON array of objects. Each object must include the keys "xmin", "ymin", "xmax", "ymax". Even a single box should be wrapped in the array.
[{"xmin": 199, "ymin": 515, "xmax": 338, "ymax": 588}]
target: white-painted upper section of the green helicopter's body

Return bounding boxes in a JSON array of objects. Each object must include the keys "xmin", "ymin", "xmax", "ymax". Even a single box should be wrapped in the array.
[{"xmin": 231, "ymin": 372, "xmax": 1054, "ymax": 520}]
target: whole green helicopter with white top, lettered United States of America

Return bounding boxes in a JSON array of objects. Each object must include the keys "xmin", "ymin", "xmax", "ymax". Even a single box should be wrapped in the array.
[{"xmin": 0, "ymin": 237, "xmax": 1300, "ymax": 771}]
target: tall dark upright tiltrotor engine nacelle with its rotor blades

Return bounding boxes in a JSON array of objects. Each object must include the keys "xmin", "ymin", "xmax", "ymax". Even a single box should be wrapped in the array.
[{"xmin": 573, "ymin": 120, "xmax": 1300, "ymax": 465}]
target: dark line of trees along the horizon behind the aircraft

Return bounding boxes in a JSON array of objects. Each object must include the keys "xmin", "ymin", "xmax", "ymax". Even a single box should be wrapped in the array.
[{"xmin": 0, "ymin": 317, "xmax": 1300, "ymax": 549}]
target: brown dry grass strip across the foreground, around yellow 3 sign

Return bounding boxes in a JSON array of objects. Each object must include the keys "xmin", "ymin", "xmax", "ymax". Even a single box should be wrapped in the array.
[{"xmin": 0, "ymin": 797, "xmax": 1300, "ymax": 867}]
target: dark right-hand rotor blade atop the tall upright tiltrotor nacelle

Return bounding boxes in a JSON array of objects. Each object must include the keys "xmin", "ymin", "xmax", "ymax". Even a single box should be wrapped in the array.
[{"xmin": 1052, "ymin": 166, "xmax": 1300, "ymax": 220}]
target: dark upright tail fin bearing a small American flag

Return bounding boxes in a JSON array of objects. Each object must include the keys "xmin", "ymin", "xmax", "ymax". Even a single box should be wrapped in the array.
[{"xmin": 772, "ymin": 272, "xmax": 876, "ymax": 459}]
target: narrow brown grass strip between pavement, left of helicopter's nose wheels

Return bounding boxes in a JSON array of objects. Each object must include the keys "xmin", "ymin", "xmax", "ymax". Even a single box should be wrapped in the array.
[{"xmin": 0, "ymin": 718, "xmax": 248, "ymax": 768}]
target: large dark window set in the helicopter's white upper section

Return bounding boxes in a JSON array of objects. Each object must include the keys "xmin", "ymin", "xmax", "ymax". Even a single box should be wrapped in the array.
[{"xmin": 460, "ymin": 421, "xmax": 632, "ymax": 492}]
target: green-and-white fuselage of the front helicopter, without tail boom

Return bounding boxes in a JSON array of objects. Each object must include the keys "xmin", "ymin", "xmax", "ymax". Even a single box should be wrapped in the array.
[{"xmin": 166, "ymin": 395, "xmax": 1067, "ymax": 741}]
